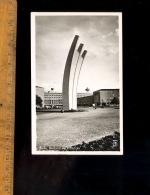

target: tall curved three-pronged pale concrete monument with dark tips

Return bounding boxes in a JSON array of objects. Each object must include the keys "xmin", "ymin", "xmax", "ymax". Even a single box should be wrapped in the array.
[{"xmin": 62, "ymin": 35, "xmax": 87, "ymax": 111}]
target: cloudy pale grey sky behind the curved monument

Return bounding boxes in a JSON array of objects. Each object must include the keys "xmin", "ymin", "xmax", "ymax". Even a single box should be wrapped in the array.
[{"xmin": 35, "ymin": 13, "xmax": 119, "ymax": 92}]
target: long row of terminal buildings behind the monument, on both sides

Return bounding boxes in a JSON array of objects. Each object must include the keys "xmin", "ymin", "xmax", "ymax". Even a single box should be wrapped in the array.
[{"xmin": 36, "ymin": 86, "xmax": 119, "ymax": 107}]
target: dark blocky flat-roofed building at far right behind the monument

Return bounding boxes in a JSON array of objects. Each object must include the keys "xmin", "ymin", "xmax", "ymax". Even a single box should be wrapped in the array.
[{"xmin": 93, "ymin": 89, "xmax": 119, "ymax": 106}]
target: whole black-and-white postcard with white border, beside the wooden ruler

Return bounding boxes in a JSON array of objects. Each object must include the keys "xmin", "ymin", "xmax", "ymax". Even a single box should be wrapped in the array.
[{"xmin": 31, "ymin": 12, "xmax": 123, "ymax": 155}]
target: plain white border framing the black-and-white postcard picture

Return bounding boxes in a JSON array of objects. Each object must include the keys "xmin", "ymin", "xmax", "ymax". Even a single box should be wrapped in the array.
[{"xmin": 31, "ymin": 12, "xmax": 123, "ymax": 155}]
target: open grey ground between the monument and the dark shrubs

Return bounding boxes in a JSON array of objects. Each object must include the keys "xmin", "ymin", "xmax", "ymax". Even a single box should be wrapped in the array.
[{"xmin": 36, "ymin": 108, "xmax": 120, "ymax": 147}]
